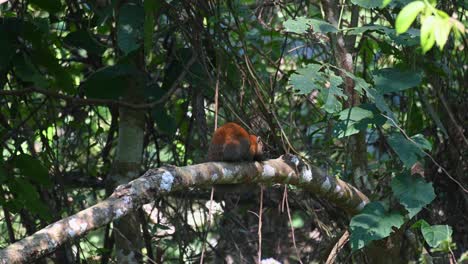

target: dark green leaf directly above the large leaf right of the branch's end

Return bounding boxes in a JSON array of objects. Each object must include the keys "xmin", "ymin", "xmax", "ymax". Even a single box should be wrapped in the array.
[{"xmin": 387, "ymin": 133, "xmax": 424, "ymax": 169}]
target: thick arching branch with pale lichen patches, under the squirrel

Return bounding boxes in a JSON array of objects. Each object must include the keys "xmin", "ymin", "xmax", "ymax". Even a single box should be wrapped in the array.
[{"xmin": 0, "ymin": 155, "xmax": 368, "ymax": 264}]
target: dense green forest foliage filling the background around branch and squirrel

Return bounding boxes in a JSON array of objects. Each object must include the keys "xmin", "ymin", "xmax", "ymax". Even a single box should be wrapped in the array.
[{"xmin": 0, "ymin": 0, "xmax": 468, "ymax": 263}]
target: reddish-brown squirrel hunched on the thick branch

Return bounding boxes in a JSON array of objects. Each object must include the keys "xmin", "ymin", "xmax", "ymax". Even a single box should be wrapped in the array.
[{"xmin": 208, "ymin": 122, "xmax": 263, "ymax": 161}]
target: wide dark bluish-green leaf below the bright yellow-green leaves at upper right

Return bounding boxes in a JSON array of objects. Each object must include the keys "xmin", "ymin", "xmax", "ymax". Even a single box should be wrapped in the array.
[{"xmin": 372, "ymin": 68, "xmax": 422, "ymax": 94}]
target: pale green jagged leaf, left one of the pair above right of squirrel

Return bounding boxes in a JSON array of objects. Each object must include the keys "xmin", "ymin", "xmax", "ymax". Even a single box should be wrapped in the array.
[{"xmin": 289, "ymin": 64, "xmax": 326, "ymax": 94}]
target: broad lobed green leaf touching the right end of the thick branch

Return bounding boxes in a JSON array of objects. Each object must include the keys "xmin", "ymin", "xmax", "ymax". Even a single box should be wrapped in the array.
[{"xmin": 349, "ymin": 202, "xmax": 404, "ymax": 251}]
